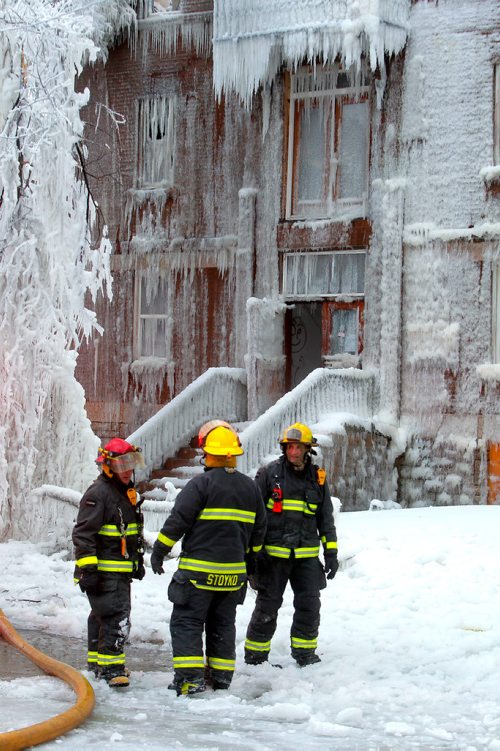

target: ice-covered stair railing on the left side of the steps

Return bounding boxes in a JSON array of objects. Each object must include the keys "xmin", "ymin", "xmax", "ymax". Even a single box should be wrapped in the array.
[{"xmin": 127, "ymin": 368, "xmax": 247, "ymax": 480}]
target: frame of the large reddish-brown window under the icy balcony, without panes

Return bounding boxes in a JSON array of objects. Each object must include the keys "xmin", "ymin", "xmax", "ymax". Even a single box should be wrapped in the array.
[{"xmin": 285, "ymin": 63, "xmax": 371, "ymax": 220}]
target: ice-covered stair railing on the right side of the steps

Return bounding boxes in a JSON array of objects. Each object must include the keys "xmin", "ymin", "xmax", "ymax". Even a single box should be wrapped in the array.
[{"xmin": 238, "ymin": 368, "xmax": 378, "ymax": 474}]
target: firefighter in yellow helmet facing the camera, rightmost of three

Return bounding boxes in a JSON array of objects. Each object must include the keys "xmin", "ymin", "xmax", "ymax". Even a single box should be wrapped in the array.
[{"xmin": 245, "ymin": 422, "xmax": 338, "ymax": 667}]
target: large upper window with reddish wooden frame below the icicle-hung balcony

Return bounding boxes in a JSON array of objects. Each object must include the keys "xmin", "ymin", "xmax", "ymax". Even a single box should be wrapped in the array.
[{"xmin": 286, "ymin": 65, "xmax": 370, "ymax": 219}]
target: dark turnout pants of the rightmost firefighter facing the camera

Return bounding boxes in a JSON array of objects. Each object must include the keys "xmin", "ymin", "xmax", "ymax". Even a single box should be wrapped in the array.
[{"xmin": 245, "ymin": 553, "xmax": 326, "ymax": 663}]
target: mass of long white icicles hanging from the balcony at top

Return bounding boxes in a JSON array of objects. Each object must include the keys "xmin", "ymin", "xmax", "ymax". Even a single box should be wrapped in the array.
[{"xmin": 213, "ymin": 0, "xmax": 410, "ymax": 106}]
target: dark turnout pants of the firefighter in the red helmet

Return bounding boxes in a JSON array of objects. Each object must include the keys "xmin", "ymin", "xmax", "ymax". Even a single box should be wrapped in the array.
[{"xmin": 87, "ymin": 574, "xmax": 131, "ymax": 674}]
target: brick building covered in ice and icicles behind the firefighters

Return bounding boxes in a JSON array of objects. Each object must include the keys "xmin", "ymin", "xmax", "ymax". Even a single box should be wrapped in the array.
[{"xmin": 77, "ymin": 0, "xmax": 500, "ymax": 508}]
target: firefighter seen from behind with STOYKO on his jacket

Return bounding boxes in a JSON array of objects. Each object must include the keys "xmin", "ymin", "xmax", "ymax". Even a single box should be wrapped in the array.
[{"xmin": 151, "ymin": 421, "xmax": 266, "ymax": 696}]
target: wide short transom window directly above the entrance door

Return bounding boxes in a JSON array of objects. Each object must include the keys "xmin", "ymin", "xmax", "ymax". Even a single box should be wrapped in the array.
[{"xmin": 283, "ymin": 251, "xmax": 365, "ymax": 300}]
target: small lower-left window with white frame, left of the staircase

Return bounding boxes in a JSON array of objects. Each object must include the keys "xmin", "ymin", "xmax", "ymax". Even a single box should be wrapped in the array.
[{"xmin": 135, "ymin": 275, "xmax": 172, "ymax": 359}]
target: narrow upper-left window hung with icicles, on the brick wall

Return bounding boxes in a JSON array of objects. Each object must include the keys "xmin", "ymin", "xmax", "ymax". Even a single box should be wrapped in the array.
[{"xmin": 137, "ymin": 96, "xmax": 175, "ymax": 188}]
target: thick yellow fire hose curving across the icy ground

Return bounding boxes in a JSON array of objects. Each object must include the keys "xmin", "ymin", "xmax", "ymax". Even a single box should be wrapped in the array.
[{"xmin": 0, "ymin": 609, "xmax": 95, "ymax": 751}]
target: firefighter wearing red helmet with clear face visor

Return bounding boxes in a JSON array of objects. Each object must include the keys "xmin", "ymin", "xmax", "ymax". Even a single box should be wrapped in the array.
[{"xmin": 73, "ymin": 438, "xmax": 145, "ymax": 688}]
